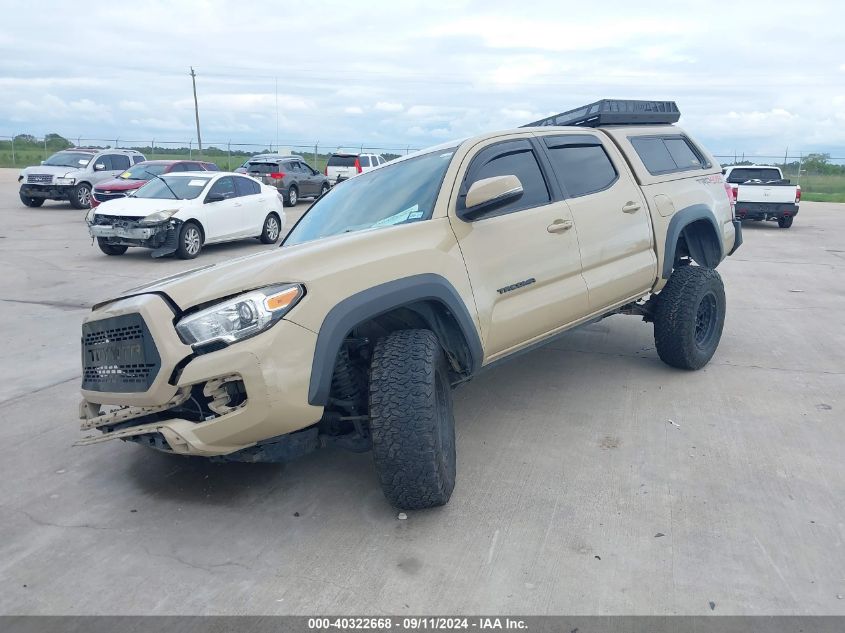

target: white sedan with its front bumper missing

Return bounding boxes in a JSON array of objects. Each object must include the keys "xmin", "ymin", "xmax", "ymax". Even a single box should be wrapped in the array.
[{"xmin": 85, "ymin": 172, "xmax": 285, "ymax": 259}]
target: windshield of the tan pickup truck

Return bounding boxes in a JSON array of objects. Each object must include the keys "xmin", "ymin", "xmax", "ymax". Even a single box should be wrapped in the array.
[{"xmin": 283, "ymin": 148, "xmax": 455, "ymax": 246}]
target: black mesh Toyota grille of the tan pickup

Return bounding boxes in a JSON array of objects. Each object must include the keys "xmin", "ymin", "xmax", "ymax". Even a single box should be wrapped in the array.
[{"xmin": 82, "ymin": 313, "xmax": 161, "ymax": 393}]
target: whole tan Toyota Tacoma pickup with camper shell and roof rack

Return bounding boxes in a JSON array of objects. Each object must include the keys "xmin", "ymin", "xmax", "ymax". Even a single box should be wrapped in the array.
[{"xmin": 78, "ymin": 100, "xmax": 741, "ymax": 509}]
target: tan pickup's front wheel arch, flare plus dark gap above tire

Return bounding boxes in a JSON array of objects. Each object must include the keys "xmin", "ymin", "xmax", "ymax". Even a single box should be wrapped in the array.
[{"xmin": 308, "ymin": 273, "xmax": 483, "ymax": 406}]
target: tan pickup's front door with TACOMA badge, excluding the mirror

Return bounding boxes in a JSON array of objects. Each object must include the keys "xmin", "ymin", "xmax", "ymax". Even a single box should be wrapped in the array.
[{"xmin": 450, "ymin": 136, "xmax": 588, "ymax": 361}]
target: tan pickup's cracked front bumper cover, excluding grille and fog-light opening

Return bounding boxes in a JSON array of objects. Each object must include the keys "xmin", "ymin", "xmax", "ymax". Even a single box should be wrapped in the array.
[{"xmin": 76, "ymin": 295, "xmax": 322, "ymax": 457}]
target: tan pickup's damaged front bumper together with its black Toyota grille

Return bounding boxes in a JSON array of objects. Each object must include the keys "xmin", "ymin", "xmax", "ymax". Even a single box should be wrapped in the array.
[{"xmin": 76, "ymin": 295, "xmax": 323, "ymax": 461}]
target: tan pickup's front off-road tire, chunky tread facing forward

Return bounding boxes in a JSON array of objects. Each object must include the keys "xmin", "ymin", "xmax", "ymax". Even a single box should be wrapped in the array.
[{"xmin": 369, "ymin": 330, "xmax": 455, "ymax": 510}]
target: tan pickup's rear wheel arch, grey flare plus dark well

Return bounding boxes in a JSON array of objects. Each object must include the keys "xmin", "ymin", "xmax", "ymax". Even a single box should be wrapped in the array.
[{"xmin": 662, "ymin": 204, "xmax": 725, "ymax": 279}]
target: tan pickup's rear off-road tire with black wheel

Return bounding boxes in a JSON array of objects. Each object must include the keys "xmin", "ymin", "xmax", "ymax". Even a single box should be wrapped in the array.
[{"xmin": 654, "ymin": 266, "xmax": 725, "ymax": 369}]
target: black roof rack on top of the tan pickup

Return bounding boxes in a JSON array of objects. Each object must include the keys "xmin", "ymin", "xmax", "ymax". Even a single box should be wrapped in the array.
[{"xmin": 522, "ymin": 99, "xmax": 681, "ymax": 127}]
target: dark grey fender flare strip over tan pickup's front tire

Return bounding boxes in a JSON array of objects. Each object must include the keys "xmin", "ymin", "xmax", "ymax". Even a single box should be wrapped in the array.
[{"xmin": 308, "ymin": 273, "xmax": 484, "ymax": 406}]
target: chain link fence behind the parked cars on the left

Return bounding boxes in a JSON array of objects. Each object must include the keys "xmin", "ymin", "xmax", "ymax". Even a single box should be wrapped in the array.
[{"xmin": 0, "ymin": 134, "xmax": 419, "ymax": 171}]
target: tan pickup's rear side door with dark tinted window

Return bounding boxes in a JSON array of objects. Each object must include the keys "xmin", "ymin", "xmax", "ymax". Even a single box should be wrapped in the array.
[{"xmin": 539, "ymin": 132, "xmax": 657, "ymax": 312}]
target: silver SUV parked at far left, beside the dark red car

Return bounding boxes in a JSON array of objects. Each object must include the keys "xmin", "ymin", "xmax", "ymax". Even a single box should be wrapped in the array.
[{"xmin": 18, "ymin": 147, "xmax": 147, "ymax": 209}]
